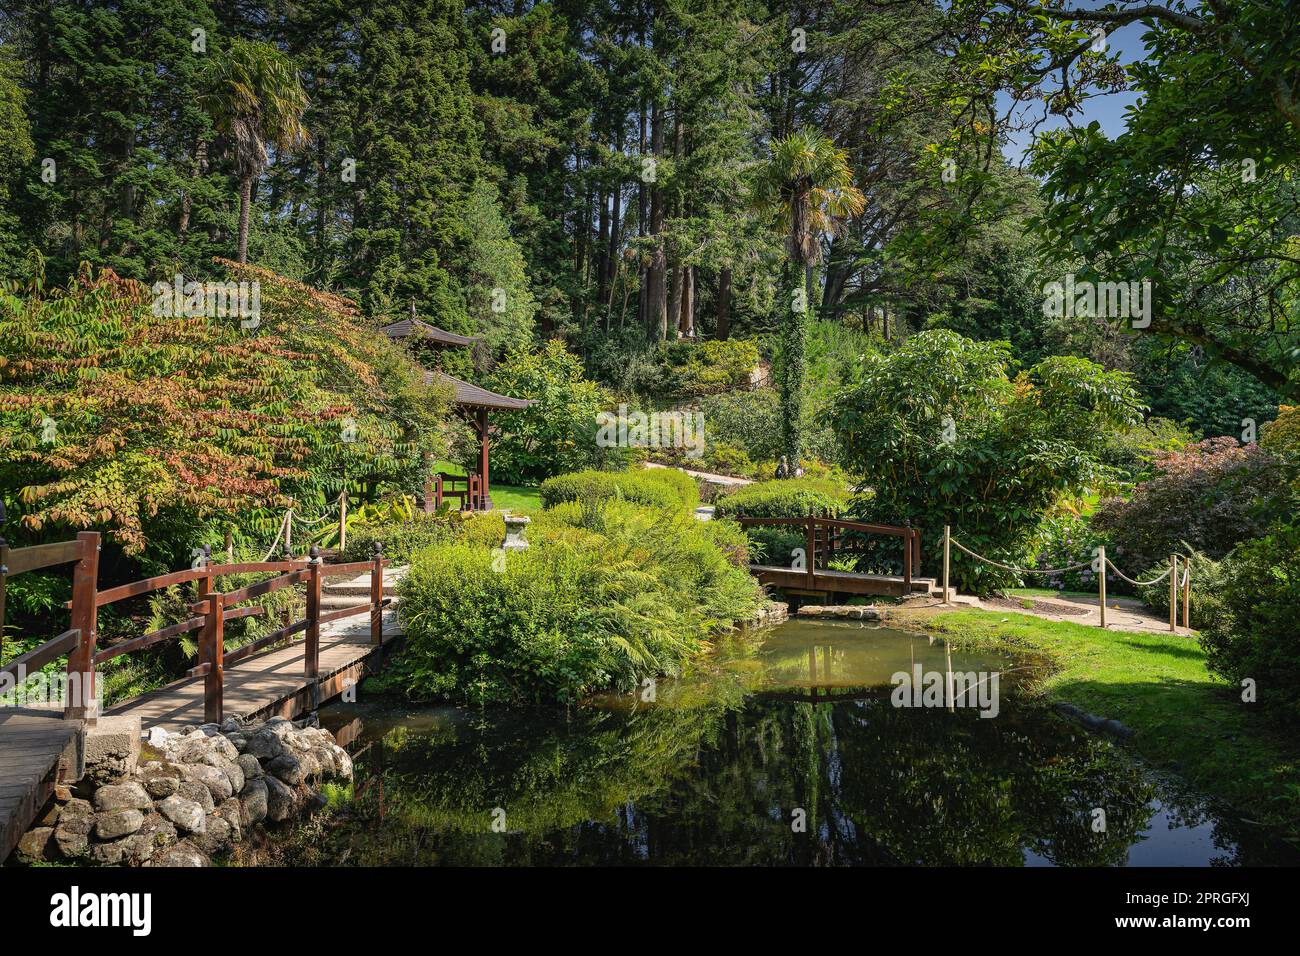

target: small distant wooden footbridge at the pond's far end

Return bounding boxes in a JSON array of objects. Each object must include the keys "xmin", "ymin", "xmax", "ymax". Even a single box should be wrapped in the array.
[{"xmin": 736, "ymin": 518, "xmax": 939, "ymax": 597}]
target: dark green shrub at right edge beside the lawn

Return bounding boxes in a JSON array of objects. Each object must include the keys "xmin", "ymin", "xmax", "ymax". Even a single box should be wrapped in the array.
[{"xmin": 1192, "ymin": 524, "xmax": 1300, "ymax": 727}]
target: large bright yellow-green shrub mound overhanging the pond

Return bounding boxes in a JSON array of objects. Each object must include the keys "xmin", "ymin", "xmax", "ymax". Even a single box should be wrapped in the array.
[{"xmin": 394, "ymin": 501, "xmax": 762, "ymax": 705}]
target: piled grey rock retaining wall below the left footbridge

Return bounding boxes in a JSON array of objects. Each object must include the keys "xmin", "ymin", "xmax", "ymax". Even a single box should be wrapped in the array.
[{"xmin": 16, "ymin": 717, "xmax": 352, "ymax": 866}]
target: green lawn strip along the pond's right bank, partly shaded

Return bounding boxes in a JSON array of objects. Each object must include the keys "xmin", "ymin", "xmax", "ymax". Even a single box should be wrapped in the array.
[{"xmin": 917, "ymin": 610, "xmax": 1300, "ymax": 836}]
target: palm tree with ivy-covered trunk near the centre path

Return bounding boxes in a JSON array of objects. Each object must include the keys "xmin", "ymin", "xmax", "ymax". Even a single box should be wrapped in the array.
[{"xmin": 754, "ymin": 130, "xmax": 867, "ymax": 470}]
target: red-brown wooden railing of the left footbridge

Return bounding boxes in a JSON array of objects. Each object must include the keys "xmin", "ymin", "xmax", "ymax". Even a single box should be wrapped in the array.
[{"xmin": 0, "ymin": 531, "xmax": 389, "ymax": 722}]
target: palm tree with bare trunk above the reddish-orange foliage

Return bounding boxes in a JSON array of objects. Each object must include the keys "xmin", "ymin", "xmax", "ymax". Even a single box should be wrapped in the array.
[{"xmin": 200, "ymin": 39, "xmax": 308, "ymax": 263}]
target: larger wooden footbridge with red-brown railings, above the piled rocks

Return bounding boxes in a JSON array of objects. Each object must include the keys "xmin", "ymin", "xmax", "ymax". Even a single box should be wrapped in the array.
[{"xmin": 0, "ymin": 532, "xmax": 399, "ymax": 862}]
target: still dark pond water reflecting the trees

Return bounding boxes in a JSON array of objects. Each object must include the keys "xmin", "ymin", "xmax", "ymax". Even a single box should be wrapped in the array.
[{"xmin": 250, "ymin": 622, "xmax": 1296, "ymax": 866}]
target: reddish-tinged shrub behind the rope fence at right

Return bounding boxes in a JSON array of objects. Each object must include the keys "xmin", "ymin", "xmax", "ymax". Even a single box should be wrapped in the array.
[{"xmin": 1092, "ymin": 437, "xmax": 1287, "ymax": 580}]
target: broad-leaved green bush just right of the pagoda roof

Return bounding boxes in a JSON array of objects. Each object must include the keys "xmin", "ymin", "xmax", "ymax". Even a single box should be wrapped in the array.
[{"xmin": 486, "ymin": 339, "xmax": 610, "ymax": 485}]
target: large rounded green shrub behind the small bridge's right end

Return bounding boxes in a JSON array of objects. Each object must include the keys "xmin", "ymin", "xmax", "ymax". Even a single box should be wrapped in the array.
[{"xmin": 835, "ymin": 330, "xmax": 1140, "ymax": 592}]
